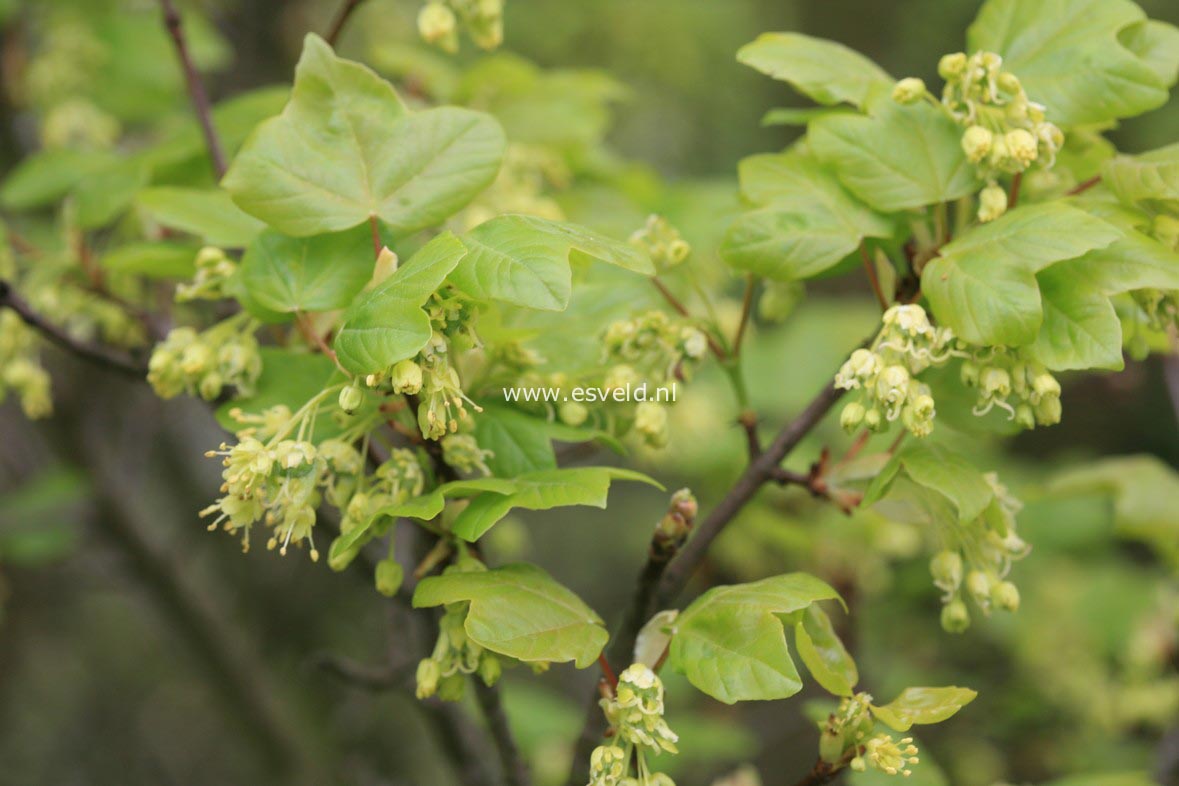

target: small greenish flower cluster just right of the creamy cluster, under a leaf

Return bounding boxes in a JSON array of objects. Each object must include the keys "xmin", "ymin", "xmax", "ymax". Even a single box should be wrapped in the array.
[{"xmin": 961, "ymin": 349, "xmax": 1061, "ymax": 429}]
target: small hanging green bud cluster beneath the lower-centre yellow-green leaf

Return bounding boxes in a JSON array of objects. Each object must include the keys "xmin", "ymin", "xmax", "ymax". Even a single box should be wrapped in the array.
[{"xmin": 417, "ymin": 559, "xmax": 503, "ymax": 701}]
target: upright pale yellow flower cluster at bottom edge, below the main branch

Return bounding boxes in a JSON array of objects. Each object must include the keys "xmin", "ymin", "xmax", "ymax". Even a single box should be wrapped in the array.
[{"xmin": 590, "ymin": 663, "xmax": 679, "ymax": 786}]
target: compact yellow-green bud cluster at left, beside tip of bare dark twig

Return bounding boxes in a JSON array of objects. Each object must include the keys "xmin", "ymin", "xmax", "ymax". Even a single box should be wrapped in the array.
[{"xmin": 147, "ymin": 315, "xmax": 262, "ymax": 401}]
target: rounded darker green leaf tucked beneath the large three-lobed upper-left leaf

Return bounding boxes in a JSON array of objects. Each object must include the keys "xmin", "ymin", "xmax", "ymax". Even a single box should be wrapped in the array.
[{"xmin": 239, "ymin": 229, "xmax": 374, "ymax": 313}]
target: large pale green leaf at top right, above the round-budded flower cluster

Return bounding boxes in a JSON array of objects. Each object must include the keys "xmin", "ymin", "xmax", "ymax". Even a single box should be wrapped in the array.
[{"xmin": 967, "ymin": 0, "xmax": 1167, "ymax": 126}]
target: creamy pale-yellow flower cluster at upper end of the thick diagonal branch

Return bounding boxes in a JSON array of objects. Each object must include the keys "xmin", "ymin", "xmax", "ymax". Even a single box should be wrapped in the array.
[{"xmin": 835, "ymin": 305, "xmax": 964, "ymax": 437}]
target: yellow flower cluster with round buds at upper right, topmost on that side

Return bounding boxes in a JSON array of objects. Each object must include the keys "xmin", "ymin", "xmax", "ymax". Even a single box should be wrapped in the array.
[{"xmin": 893, "ymin": 52, "xmax": 1065, "ymax": 222}]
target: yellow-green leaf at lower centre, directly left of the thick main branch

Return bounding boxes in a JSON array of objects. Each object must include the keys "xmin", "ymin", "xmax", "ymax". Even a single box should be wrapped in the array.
[{"xmin": 414, "ymin": 563, "xmax": 610, "ymax": 668}]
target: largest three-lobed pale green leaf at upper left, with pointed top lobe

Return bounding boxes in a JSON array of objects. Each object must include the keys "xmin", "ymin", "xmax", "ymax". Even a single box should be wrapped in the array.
[{"xmin": 223, "ymin": 35, "xmax": 506, "ymax": 237}]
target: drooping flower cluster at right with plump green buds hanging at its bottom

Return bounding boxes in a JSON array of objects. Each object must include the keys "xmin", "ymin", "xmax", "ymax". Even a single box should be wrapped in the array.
[{"xmin": 929, "ymin": 473, "xmax": 1032, "ymax": 633}]
